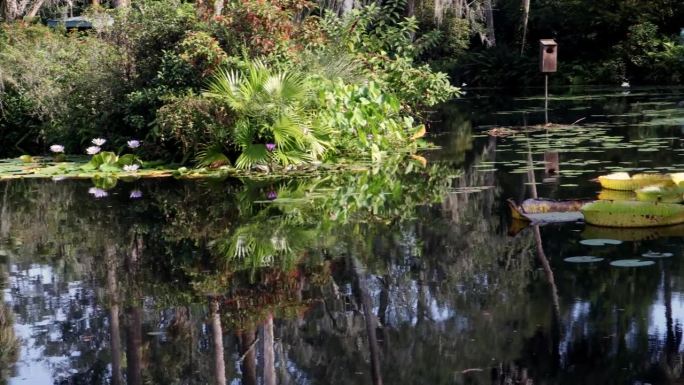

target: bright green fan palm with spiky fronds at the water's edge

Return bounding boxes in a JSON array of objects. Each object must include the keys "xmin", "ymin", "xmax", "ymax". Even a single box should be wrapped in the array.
[{"xmin": 205, "ymin": 61, "xmax": 328, "ymax": 168}]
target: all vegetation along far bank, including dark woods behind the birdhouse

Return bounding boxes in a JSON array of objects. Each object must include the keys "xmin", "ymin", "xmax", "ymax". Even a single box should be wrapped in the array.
[{"xmin": 0, "ymin": 0, "xmax": 684, "ymax": 174}]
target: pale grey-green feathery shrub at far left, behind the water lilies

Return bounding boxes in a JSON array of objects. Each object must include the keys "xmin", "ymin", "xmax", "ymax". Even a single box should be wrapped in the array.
[{"xmin": 0, "ymin": 24, "xmax": 124, "ymax": 152}]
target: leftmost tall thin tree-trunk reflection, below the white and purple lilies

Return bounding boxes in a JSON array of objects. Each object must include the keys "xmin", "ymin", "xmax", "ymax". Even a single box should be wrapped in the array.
[{"xmin": 106, "ymin": 246, "xmax": 122, "ymax": 385}]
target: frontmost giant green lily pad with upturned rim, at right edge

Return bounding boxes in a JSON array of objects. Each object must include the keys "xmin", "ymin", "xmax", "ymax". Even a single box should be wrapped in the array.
[{"xmin": 582, "ymin": 201, "xmax": 684, "ymax": 227}]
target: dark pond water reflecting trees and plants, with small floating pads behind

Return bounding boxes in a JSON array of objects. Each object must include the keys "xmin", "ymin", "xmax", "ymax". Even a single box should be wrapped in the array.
[{"xmin": 0, "ymin": 89, "xmax": 684, "ymax": 385}]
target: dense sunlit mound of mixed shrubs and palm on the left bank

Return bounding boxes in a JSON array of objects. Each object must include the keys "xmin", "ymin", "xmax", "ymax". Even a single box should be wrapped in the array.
[{"xmin": 0, "ymin": 0, "xmax": 457, "ymax": 170}]
